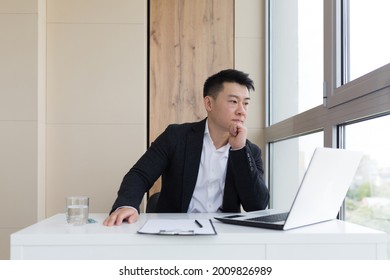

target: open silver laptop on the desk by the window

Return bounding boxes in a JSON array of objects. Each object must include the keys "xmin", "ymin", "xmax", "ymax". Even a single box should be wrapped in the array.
[{"xmin": 215, "ymin": 148, "xmax": 363, "ymax": 230}]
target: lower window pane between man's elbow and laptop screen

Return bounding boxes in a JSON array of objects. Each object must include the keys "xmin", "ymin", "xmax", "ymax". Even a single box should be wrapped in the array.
[{"xmin": 270, "ymin": 131, "xmax": 324, "ymax": 210}]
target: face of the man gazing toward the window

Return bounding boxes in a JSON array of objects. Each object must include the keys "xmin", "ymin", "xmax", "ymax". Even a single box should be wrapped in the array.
[{"xmin": 204, "ymin": 82, "xmax": 250, "ymax": 130}]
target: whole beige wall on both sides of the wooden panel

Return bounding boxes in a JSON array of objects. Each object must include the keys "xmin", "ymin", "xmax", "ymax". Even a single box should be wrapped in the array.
[{"xmin": 0, "ymin": 0, "xmax": 264, "ymax": 259}]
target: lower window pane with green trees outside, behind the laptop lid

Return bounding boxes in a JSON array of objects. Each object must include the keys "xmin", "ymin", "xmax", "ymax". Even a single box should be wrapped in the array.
[{"xmin": 344, "ymin": 115, "xmax": 390, "ymax": 256}]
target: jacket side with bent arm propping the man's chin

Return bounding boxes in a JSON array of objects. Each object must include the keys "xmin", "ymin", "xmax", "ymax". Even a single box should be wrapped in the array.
[{"xmin": 223, "ymin": 142, "xmax": 269, "ymax": 212}]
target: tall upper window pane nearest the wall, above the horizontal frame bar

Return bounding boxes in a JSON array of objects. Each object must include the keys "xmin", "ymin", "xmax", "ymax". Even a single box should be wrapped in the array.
[{"xmin": 269, "ymin": 0, "xmax": 323, "ymax": 124}]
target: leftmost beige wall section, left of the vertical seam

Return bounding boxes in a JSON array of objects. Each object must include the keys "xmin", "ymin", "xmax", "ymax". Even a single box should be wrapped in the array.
[{"xmin": 0, "ymin": 0, "xmax": 45, "ymax": 259}]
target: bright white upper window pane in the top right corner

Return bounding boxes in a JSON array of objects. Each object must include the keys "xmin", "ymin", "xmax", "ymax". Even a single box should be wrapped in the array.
[{"xmin": 349, "ymin": 0, "xmax": 390, "ymax": 80}]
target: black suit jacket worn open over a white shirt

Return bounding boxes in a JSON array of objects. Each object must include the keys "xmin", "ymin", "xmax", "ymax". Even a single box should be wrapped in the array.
[{"xmin": 111, "ymin": 119, "xmax": 269, "ymax": 213}]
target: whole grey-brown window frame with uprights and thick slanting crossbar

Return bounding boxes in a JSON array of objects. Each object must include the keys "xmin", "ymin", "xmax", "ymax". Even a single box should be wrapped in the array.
[{"xmin": 264, "ymin": 0, "xmax": 390, "ymax": 207}]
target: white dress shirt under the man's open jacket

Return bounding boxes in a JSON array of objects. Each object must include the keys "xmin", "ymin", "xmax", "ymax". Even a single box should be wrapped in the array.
[{"xmin": 188, "ymin": 120, "xmax": 230, "ymax": 213}]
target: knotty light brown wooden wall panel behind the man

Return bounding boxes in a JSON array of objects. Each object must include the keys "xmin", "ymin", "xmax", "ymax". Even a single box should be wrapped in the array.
[{"xmin": 149, "ymin": 0, "xmax": 234, "ymax": 193}]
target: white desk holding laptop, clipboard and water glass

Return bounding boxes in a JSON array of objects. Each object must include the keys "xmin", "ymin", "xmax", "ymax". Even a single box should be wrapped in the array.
[{"xmin": 11, "ymin": 214, "xmax": 387, "ymax": 260}]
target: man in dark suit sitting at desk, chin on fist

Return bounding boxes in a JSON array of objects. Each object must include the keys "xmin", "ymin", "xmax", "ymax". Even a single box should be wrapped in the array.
[{"xmin": 104, "ymin": 69, "xmax": 269, "ymax": 226}]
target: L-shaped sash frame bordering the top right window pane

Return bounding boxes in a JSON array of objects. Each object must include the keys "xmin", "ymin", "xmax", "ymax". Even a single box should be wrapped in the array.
[{"xmin": 323, "ymin": 0, "xmax": 390, "ymax": 108}]
